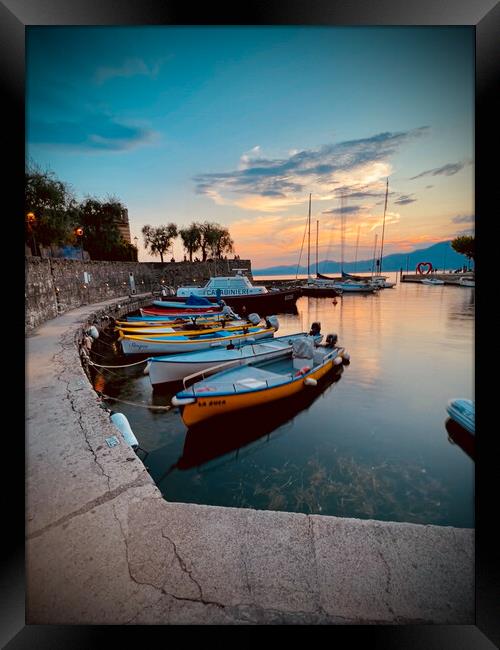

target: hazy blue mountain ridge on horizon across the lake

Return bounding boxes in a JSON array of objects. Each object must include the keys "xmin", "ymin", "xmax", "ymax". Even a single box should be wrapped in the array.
[{"xmin": 252, "ymin": 241, "xmax": 468, "ymax": 276}]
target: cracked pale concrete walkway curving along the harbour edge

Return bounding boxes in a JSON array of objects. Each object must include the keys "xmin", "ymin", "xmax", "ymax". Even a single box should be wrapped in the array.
[{"xmin": 26, "ymin": 298, "xmax": 474, "ymax": 625}]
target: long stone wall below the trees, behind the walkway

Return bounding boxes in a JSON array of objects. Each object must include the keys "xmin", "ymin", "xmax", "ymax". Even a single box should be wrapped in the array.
[{"xmin": 25, "ymin": 257, "xmax": 252, "ymax": 331}]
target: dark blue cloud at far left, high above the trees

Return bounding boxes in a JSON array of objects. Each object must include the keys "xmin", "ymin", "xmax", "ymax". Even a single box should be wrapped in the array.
[{"xmin": 28, "ymin": 114, "xmax": 158, "ymax": 152}]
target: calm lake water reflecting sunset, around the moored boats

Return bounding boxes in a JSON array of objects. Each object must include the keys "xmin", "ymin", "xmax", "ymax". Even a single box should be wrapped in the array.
[{"xmin": 95, "ymin": 274, "xmax": 474, "ymax": 527}]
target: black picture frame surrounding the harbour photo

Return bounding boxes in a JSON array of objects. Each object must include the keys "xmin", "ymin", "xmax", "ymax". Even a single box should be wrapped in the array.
[{"xmin": 8, "ymin": 0, "xmax": 500, "ymax": 650}]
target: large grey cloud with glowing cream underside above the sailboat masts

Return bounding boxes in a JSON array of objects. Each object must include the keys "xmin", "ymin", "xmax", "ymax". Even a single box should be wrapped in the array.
[{"xmin": 194, "ymin": 127, "xmax": 428, "ymax": 212}]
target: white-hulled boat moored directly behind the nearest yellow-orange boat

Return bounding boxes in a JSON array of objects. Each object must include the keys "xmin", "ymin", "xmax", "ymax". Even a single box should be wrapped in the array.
[{"xmin": 148, "ymin": 333, "xmax": 322, "ymax": 386}]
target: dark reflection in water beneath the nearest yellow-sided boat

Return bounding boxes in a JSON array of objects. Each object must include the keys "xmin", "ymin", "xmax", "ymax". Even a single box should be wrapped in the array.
[{"xmin": 162, "ymin": 366, "xmax": 343, "ymax": 470}]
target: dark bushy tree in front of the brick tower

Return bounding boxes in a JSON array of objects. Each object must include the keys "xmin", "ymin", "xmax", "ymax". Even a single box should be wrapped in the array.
[{"xmin": 75, "ymin": 197, "xmax": 131, "ymax": 260}]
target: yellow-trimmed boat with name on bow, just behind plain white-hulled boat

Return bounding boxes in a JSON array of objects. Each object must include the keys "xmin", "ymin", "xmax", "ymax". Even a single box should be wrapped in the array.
[{"xmin": 119, "ymin": 316, "xmax": 279, "ymax": 355}]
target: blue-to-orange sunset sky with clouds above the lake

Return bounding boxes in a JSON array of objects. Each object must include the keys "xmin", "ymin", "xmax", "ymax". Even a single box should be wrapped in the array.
[{"xmin": 26, "ymin": 26, "xmax": 474, "ymax": 269}]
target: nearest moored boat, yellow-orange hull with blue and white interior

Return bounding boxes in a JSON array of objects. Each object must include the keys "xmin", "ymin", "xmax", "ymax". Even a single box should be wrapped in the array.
[{"xmin": 172, "ymin": 336, "xmax": 349, "ymax": 427}]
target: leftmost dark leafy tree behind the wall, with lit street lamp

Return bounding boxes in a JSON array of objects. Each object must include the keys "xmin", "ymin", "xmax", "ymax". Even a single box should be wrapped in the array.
[{"xmin": 25, "ymin": 163, "xmax": 79, "ymax": 253}]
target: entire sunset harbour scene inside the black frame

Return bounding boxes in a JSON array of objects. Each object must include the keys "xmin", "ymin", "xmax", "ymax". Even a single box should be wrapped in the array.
[{"xmin": 22, "ymin": 22, "xmax": 485, "ymax": 632}]
